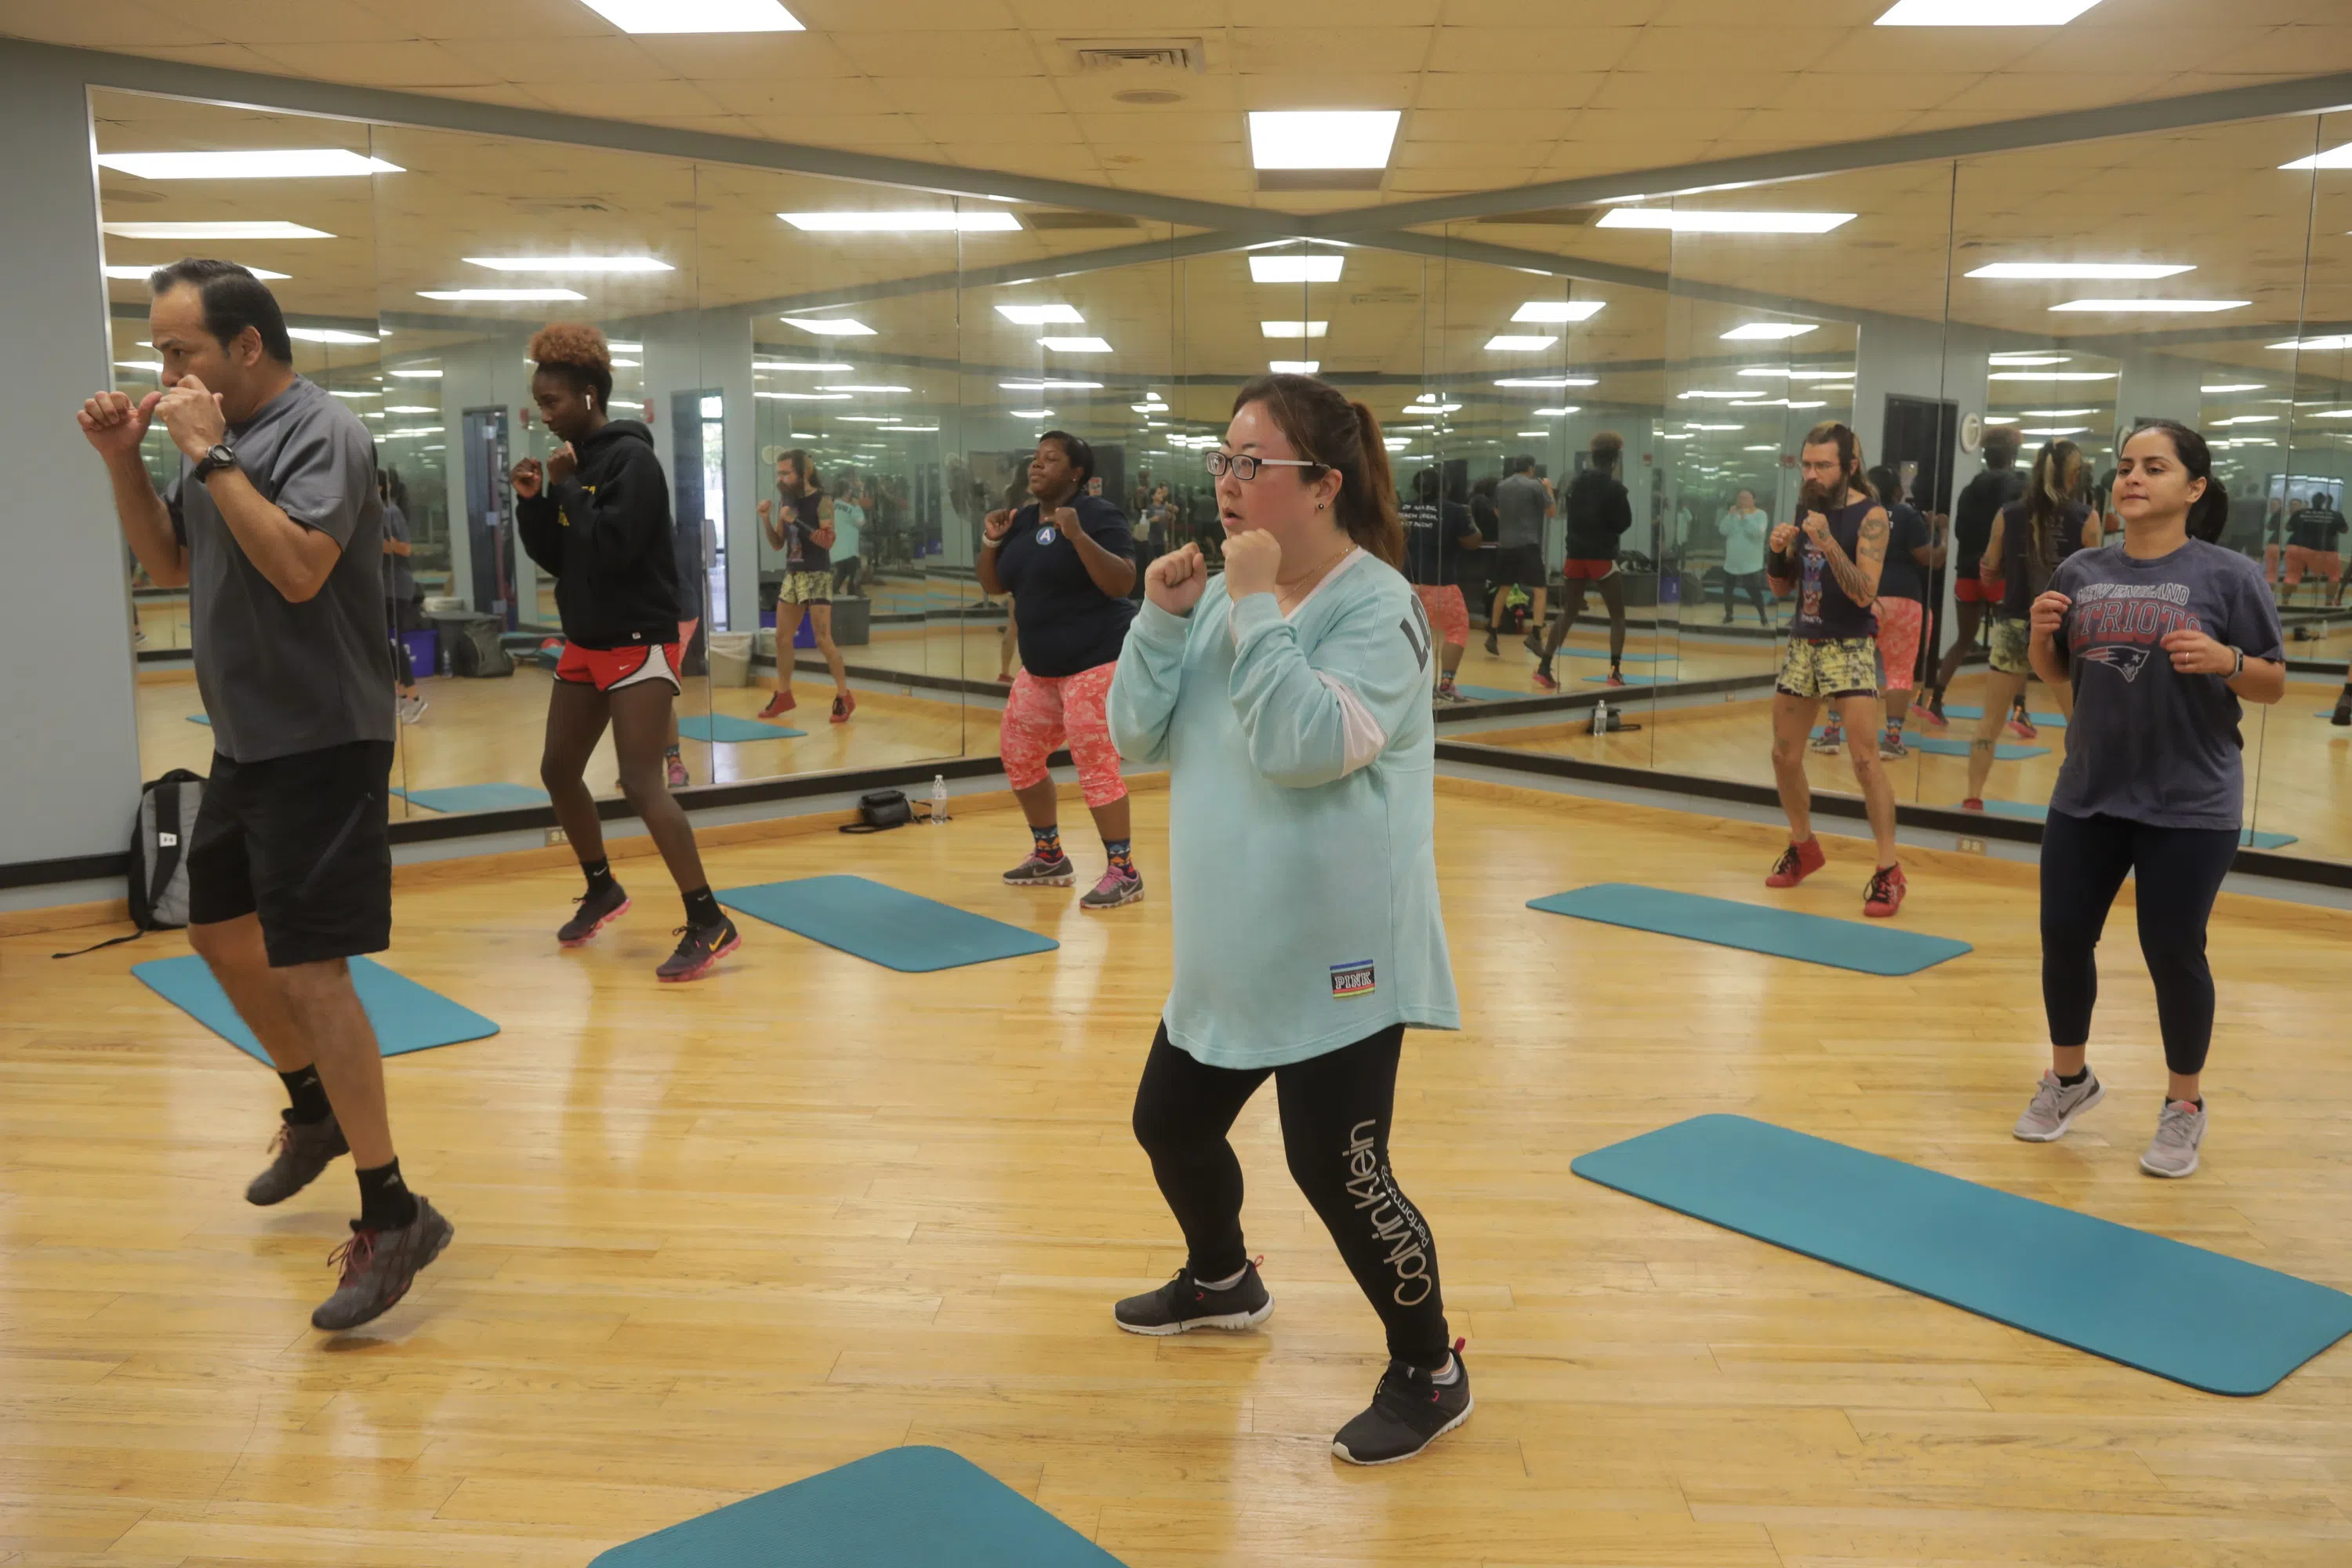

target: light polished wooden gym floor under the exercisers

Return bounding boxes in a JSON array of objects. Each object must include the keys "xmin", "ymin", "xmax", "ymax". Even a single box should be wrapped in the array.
[{"xmin": 0, "ymin": 783, "xmax": 2352, "ymax": 1568}]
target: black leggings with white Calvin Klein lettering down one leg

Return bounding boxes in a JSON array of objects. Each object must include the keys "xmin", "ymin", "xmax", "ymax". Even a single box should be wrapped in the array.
[{"xmin": 1136, "ymin": 1022, "xmax": 1446, "ymax": 1370}]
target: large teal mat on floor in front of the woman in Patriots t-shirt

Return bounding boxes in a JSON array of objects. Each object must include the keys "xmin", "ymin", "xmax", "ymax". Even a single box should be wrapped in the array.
[{"xmin": 1569, "ymin": 1116, "xmax": 2352, "ymax": 1394}]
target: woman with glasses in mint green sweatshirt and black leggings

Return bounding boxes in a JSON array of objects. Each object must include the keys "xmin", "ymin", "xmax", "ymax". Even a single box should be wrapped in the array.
[{"xmin": 1110, "ymin": 376, "xmax": 1470, "ymax": 1465}]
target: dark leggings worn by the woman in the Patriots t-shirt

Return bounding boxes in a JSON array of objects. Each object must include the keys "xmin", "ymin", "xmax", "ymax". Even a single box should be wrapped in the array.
[{"xmin": 2042, "ymin": 811, "xmax": 2239, "ymax": 1076}]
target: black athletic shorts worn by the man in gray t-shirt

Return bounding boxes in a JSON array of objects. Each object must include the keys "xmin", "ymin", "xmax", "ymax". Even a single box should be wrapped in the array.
[{"xmin": 188, "ymin": 741, "xmax": 393, "ymax": 968}]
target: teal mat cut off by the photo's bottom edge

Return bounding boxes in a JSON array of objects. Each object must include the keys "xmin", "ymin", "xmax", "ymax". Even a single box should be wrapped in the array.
[{"xmin": 588, "ymin": 1446, "xmax": 1122, "ymax": 1568}]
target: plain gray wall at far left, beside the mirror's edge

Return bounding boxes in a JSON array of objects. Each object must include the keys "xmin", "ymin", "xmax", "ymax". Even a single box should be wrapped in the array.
[{"xmin": 0, "ymin": 47, "xmax": 139, "ymax": 865}]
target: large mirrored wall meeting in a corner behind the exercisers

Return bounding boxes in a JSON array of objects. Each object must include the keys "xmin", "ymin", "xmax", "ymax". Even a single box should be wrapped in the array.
[{"xmin": 94, "ymin": 92, "xmax": 2352, "ymax": 858}]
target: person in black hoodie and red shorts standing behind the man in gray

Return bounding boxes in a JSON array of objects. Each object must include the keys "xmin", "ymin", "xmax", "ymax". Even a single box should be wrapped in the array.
[{"xmin": 513, "ymin": 322, "xmax": 741, "ymax": 980}]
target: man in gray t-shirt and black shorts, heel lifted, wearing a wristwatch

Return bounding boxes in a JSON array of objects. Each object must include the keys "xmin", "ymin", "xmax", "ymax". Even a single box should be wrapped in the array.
[{"xmin": 80, "ymin": 261, "xmax": 454, "ymax": 1330}]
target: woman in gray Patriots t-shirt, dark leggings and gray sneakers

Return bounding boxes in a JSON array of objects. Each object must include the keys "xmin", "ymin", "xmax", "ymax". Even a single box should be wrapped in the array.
[{"xmin": 2016, "ymin": 419, "xmax": 2286, "ymax": 1175}]
